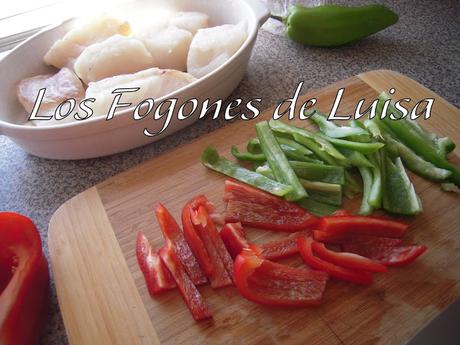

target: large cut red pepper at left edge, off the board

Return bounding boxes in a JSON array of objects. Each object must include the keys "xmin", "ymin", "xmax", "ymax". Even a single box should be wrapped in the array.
[{"xmin": 0, "ymin": 212, "xmax": 49, "ymax": 345}]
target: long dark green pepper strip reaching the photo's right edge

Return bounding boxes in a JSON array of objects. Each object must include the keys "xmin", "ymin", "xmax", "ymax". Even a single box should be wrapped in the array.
[{"xmin": 377, "ymin": 95, "xmax": 460, "ymax": 186}]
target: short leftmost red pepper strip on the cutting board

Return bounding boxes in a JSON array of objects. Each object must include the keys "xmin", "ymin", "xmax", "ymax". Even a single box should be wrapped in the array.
[{"xmin": 136, "ymin": 231, "xmax": 177, "ymax": 296}]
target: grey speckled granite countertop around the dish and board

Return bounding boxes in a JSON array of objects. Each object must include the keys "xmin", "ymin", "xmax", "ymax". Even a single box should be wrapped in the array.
[{"xmin": 0, "ymin": 0, "xmax": 460, "ymax": 344}]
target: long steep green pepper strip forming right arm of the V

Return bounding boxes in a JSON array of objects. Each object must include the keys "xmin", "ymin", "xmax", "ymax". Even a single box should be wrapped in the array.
[{"xmin": 256, "ymin": 121, "xmax": 308, "ymax": 201}]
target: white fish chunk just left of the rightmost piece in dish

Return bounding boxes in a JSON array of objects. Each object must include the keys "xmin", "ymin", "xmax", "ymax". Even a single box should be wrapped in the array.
[{"xmin": 140, "ymin": 27, "xmax": 193, "ymax": 71}]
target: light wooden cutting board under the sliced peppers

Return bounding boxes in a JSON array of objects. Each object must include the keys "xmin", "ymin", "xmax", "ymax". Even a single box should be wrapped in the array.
[{"xmin": 48, "ymin": 71, "xmax": 460, "ymax": 345}]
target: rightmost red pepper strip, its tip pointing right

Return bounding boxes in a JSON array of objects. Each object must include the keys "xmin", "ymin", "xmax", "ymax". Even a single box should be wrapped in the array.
[{"xmin": 342, "ymin": 237, "xmax": 427, "ymax": 266}]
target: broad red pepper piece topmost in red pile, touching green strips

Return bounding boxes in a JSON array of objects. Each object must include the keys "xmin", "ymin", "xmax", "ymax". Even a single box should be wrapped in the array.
[{"xmin": 224, "ymin": 180, "xmax": 318, "ymax": 232}]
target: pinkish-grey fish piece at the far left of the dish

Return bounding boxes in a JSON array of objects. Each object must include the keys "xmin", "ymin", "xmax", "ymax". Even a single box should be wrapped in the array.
[{"xmin": 16, "ymin": 67, "xmax": 85, "ymax": 126}]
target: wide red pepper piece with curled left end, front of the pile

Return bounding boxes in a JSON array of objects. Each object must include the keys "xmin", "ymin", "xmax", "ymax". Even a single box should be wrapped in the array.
[{"xmin": 235, "ymin": 250, "xmax": 328, "ymax": 307}]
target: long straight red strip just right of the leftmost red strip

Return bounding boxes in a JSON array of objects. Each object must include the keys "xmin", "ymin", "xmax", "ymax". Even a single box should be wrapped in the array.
[{"xmin": 155, "ymin": 204, "xmax": 207, "ymax": 285}]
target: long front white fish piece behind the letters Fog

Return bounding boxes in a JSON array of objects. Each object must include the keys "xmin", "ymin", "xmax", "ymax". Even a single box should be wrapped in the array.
[{"xmin": 85, "ymin": 68, "xmax": 196, "ymax": 116}]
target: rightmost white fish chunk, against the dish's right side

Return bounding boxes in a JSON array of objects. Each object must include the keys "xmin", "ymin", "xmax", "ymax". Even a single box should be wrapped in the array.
[{"xmin": 187, "ymin": 21, "xmax": 247, "ymax": 78}]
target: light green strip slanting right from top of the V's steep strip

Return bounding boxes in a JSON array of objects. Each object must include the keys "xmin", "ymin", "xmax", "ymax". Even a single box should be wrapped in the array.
[{"xmin": 269, "ymin": 120, "xmax": 346, "ymax": 165}]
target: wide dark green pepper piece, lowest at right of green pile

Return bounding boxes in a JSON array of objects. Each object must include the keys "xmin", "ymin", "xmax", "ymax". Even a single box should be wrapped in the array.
[{"xmin": 382, "ymin": 153, "xmax": 422, "ymax": 216}]
